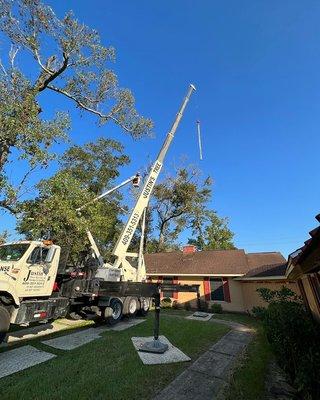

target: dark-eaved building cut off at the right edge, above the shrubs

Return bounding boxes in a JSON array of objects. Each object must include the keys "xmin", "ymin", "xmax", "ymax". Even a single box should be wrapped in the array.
[{"xmin": 286, "ymin": 214, "xmax": 320, "ymax": 321}]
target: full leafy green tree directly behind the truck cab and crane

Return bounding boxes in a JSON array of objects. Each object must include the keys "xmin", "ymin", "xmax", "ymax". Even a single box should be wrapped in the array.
[{"xmin": 18, "ymin": 138, "xmax": 129, "ymax": 254}]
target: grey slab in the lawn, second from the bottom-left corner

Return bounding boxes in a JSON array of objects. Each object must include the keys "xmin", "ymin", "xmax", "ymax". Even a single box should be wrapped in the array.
[{"xmin": 41, "ymin": 328, "xmax": 100, "ymax": 350}]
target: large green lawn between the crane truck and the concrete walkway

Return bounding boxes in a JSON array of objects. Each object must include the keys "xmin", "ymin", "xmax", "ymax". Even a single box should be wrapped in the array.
[{"xmin": 0, "ymin": 313, "xmax": 229, "ymax": 400}]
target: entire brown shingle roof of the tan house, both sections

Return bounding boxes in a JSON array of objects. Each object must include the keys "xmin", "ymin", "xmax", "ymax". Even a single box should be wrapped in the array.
[{"xmin": 145, "ymin": 250, "xmax": 286, "ymax": 276}]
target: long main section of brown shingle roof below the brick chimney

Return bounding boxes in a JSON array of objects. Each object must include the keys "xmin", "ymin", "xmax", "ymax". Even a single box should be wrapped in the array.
[{"xmin": 144, "ymin": 250, "xmax": 249, "ymax": 275}]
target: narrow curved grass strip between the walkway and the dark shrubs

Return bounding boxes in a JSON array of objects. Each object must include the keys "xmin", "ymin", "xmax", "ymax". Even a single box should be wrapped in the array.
[{"xmin": 217, "ymin": 314, "xmax": 273, "ymax": 400}]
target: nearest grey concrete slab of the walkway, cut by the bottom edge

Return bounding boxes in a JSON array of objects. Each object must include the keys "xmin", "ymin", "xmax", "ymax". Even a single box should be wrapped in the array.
[{"xmin": 153, "ymin": 368, "xmax": 226, "ymax": 400}]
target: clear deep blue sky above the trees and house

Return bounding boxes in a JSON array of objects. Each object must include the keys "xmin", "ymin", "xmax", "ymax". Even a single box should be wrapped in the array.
[{"xmin": 0, "ymin": 0, "xmax": 320, "ymax": 256}]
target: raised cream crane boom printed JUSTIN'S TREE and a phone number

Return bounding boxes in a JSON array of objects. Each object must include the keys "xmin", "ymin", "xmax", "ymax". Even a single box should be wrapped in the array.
[{"xmin": 113, "ymin": 84, "xmax": 196, "ymax": 282}]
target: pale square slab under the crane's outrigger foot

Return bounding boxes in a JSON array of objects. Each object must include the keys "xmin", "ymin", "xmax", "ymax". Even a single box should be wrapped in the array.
[{"xmin": 131, "ymin": 336, "xmax": 191, "ymax": 365}]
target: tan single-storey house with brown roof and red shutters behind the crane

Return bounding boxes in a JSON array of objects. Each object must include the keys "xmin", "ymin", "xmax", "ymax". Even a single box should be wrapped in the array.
[{"xmin": 145, "ymin": 245, "xmax": 299, "ymax": 312}]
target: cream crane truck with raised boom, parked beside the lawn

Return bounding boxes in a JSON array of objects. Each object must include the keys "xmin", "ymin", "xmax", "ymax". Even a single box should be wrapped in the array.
[{"xmin": 0, "ymin": 85, "xmax": 195, "ymax": 343}]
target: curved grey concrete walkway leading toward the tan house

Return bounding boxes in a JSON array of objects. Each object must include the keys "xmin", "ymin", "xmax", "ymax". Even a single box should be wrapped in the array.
[{"xmin": 154, "ymin": 319, "xmax": 253, "ymax": 400}]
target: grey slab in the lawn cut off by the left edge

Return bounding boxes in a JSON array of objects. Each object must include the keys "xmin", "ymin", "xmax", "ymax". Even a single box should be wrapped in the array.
[{"xmin": 0, "ymin": 346, "xmax": 56, "ymax": 378}]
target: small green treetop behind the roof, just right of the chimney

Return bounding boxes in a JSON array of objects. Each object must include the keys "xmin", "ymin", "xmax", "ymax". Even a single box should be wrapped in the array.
[{"xmin": 188, "ymin": 210, "xmax": 235, "ymax": 250}]
